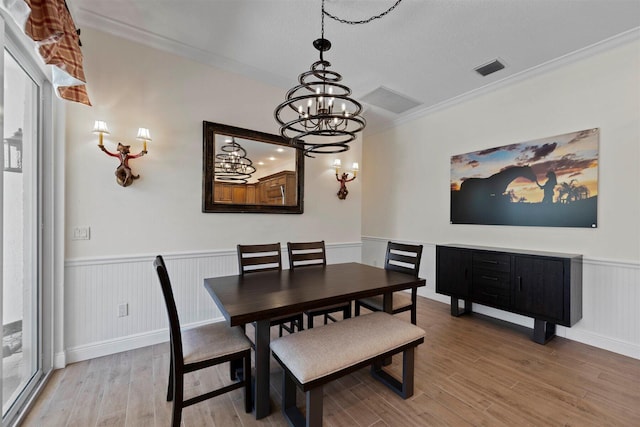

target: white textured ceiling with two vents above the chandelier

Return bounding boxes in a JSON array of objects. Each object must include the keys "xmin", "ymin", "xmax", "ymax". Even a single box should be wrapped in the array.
[{"xmin": 68, "ymin": 0, "xmax": 640, "ymax": 132}]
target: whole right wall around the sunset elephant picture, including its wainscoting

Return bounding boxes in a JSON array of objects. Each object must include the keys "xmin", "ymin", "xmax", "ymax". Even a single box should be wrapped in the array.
[{"xmin": 362, "ymin": 39, "xmax": 640, "ymax": 357}]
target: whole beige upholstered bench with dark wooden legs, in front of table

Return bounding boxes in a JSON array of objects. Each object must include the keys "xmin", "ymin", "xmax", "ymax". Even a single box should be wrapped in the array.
[{"xmin": 271, "ymin": 312, "xmax": 425, "ymax": 427}]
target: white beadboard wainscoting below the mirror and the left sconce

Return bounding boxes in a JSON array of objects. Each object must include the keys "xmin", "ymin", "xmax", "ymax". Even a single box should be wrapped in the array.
[{"xmin": 63, "ymin": 242, "xmax": 361, "ymax": 367}]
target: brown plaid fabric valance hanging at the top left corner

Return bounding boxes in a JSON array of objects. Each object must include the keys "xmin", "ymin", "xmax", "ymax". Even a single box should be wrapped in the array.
[{"xmin": 24, "ymin": 0, "xmax": 91, "ymax": 105}]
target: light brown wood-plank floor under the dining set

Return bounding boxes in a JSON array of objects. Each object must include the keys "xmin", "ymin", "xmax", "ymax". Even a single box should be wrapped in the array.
[{"xmin": 23, "ymin": 298, "xmax": 640, "ymax": 427}]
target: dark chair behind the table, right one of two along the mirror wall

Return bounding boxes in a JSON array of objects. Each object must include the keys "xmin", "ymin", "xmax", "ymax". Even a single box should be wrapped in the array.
[{"xmin": 287, "ymin": 240, "xmax": 351, "ymax": 329}]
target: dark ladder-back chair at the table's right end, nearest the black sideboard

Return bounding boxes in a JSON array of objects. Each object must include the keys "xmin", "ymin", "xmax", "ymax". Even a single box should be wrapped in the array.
[{"xmin": 354, "ymin": 242, "xmax": 422, "ymax": 325}]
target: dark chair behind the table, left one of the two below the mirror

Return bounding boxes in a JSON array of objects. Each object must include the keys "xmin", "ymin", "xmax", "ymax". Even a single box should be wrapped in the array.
[{"xmin": 238, "ymin": 243, "xmax": 304, "ymax": 336}]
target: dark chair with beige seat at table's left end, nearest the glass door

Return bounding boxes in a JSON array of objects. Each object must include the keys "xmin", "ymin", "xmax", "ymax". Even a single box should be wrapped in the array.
[{"xmin": 153, "ymin": 255, "xmax": 253, "ymax": 427}]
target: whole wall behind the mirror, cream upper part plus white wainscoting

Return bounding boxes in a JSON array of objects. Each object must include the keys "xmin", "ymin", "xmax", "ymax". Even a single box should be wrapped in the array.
[{"xmin": 62, "ymin": 28, "xmax": 361, "ymax": 366}]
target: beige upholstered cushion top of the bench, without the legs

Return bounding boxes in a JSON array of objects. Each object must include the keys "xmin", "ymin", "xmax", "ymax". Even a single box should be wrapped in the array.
[{"xmin": 271, "ymin": 312, "xmax": 425, "ymax": 384}]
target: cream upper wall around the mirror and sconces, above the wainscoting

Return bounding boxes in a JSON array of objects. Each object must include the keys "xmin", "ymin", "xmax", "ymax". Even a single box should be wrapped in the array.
[{"xmin": 66, "ymin": 28, "xmax": 361, "ymax": 259}]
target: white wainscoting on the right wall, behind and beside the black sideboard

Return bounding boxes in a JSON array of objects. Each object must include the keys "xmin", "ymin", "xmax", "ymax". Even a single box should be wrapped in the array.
[{"xmin": 362, "ymin": 237, "xmax": 640, "ymax": 359}]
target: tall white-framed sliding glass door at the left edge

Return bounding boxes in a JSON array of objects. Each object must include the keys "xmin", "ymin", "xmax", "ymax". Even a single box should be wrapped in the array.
[{"xmin": 0, "ymin": 15, "xmax": 53, "ymax": 425}]
